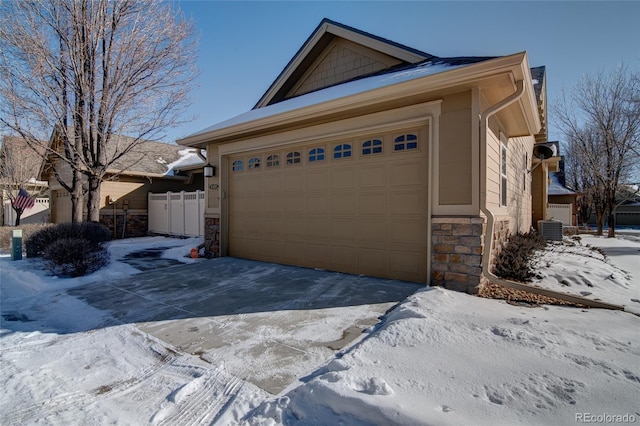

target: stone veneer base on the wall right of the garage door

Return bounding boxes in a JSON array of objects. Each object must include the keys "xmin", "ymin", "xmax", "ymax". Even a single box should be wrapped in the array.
[{"xmin": 431, "ymin": 217, "xmax": 485, "ymax": 294}]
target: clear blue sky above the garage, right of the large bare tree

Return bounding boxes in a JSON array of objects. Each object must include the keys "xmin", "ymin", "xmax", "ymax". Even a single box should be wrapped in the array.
[{"xmin": 165, "ymin": 0, "xmax": 640, "ymax": 141}]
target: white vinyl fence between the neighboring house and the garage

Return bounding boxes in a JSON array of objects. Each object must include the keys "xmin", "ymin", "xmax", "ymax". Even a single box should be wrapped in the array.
[{"xmin": 148, "ymin": 191, "xmax": 204, "ymax": 237}]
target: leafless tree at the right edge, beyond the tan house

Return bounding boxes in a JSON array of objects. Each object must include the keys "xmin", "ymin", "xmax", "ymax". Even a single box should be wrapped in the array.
[{"xmin": 554, "ymin": 66, "xmax": 640, "ymax": 237}]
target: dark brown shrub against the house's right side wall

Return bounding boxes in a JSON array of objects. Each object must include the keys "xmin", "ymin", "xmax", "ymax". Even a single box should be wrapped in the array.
[{"xmin": 495, "ymin": 231, "xmax": 545, "ymax": 282}]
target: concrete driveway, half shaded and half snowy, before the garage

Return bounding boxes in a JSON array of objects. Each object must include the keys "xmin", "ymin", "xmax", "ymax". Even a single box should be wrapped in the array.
[{"xmin": 69, "ymin": 257, "xmax": 423, "ymax": 395}]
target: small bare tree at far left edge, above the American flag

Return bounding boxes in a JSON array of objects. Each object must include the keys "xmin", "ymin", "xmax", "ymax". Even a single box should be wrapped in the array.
[{"xmin": 0, "ymin": 136, "xmax": 48, "ymax": 226}]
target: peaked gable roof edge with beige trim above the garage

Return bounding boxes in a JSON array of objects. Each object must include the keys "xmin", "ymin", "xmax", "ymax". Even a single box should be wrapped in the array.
[{"xmin": 254, "ymin": 18, "xmax": 434, "ymax": 109}]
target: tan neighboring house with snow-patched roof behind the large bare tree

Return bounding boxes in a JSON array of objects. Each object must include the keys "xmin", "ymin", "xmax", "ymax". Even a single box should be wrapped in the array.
[{"xmin": 45, "ymin": 132, "xmax": 204, "ymax": 238}]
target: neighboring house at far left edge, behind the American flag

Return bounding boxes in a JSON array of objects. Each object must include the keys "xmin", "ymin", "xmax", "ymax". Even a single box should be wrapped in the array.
[{"xmin": 0, "ymin": 136, "xmax": 49, "ymax": 226}]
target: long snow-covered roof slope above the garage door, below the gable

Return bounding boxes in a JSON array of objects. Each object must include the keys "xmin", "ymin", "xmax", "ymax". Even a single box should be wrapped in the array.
[{"xmin": 189, "ymin": 58, "xmax": 470, "ymax": 136}]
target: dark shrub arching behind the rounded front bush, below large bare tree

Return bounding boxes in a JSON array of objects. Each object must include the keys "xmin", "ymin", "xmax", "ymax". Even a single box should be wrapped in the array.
[{"xmin": 25, "ymin": 222, "xmax": 111, "ymax": 257}]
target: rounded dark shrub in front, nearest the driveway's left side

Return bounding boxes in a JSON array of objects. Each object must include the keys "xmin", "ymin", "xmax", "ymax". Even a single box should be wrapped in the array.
[{"xmin": 42, "ymin": 238, "xmax": 109, "ymax": 277}]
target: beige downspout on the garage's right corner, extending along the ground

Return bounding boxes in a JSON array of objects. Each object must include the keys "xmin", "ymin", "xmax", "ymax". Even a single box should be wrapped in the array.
[{"xmin": 479, "ymin": 80, "xmax": 624, "ymax": 310}]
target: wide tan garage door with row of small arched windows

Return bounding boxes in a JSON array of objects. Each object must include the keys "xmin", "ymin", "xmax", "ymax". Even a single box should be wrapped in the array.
[{"xmin": 228, "ymin": 129, "xmax": 428, "ymax": 282}]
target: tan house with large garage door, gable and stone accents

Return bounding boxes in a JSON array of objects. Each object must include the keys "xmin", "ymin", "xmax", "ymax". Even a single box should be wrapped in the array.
[{"xmin": 178, "ymin": 20, "xmax": 548, "ymax": 292}]
